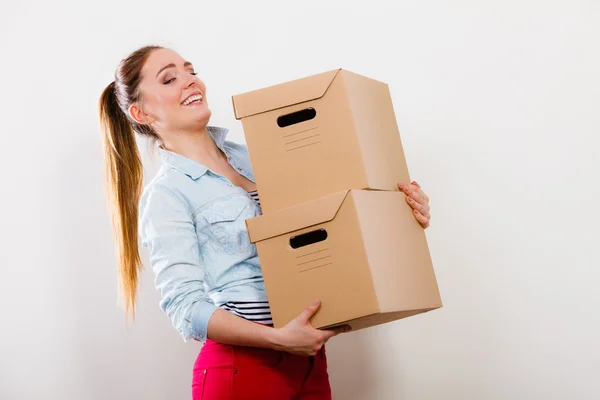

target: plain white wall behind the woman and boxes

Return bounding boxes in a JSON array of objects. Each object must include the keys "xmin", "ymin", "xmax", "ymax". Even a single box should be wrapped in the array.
[{"xmin": 0, "ymin": 0, "xmax": 600, "ymax": 400}]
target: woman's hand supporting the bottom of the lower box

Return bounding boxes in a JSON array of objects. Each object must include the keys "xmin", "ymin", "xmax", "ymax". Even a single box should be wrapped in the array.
[{"xmin": 273, "ymin": 300, "xmax": 351, "ymax": 356}]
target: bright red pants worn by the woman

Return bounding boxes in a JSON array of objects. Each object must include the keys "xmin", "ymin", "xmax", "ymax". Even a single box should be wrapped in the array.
[{"xmin": 192, "ymin": 340, "xmax": 331, "ymax": 400}]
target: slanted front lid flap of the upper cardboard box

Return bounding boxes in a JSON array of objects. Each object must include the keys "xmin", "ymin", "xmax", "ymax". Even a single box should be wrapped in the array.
[{"xmin": 232, "ymin": 69, "xmax": 340, "ymax": 119}]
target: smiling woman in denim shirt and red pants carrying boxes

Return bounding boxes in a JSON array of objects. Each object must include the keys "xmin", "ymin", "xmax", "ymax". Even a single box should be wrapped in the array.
[{"xmin": 100, "ymin": 46, "xmax": 429, "ymax": 400}]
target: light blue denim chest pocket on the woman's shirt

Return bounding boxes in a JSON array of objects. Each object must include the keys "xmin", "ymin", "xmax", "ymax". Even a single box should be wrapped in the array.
[{"xmin": 200, "ymin": 196, "xmax": 255, "ymax": 255}]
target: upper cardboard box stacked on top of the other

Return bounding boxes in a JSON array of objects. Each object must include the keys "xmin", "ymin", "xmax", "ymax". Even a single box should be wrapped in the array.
[{"xmin": 233, "ymin": 69, "xmax": 410, "ymax": 214}]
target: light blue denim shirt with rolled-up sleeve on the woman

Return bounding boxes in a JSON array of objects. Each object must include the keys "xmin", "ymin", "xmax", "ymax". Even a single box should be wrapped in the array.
[{"xmin": 139, "ymin": 127, "xmax": 267, "ymax": 342}]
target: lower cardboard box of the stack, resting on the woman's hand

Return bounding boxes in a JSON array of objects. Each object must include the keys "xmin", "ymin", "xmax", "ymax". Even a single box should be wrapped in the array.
[{"xmin": 246, "ymin": 190, "xmax": 442, "ymax": 329}]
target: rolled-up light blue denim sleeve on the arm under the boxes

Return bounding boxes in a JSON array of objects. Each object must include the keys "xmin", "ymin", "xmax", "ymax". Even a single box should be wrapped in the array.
[{"xmin": 139, "ymin": 183, "xmax": 217, "ymax": 342}]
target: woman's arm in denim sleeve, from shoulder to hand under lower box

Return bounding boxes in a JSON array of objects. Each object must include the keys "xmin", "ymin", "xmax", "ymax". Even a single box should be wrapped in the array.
[{"xmin": 140, "ymin": 184, "xmax": 347, "ymax": 354}]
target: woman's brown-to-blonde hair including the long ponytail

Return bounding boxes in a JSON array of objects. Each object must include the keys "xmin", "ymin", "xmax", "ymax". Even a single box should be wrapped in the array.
[{"xmin": 99, "ymin": 46, "xmax": 162, "ymax": 318}]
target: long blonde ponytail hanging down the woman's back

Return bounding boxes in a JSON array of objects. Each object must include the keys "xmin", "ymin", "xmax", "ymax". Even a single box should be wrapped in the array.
[{"xmin": 100, "ymin": 82, "xmax": 143, "ymax": 318}]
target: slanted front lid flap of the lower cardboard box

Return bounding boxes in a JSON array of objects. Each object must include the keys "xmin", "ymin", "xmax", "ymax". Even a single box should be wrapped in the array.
[{"xmin": 246, "ymin": 190, "xmax": 349, "ymax": 243}]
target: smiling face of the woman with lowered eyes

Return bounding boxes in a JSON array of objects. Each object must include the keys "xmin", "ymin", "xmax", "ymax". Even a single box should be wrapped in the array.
[{"xmin": 129, "ymin": 49, "xmax": 211, "ymax": 134}]
